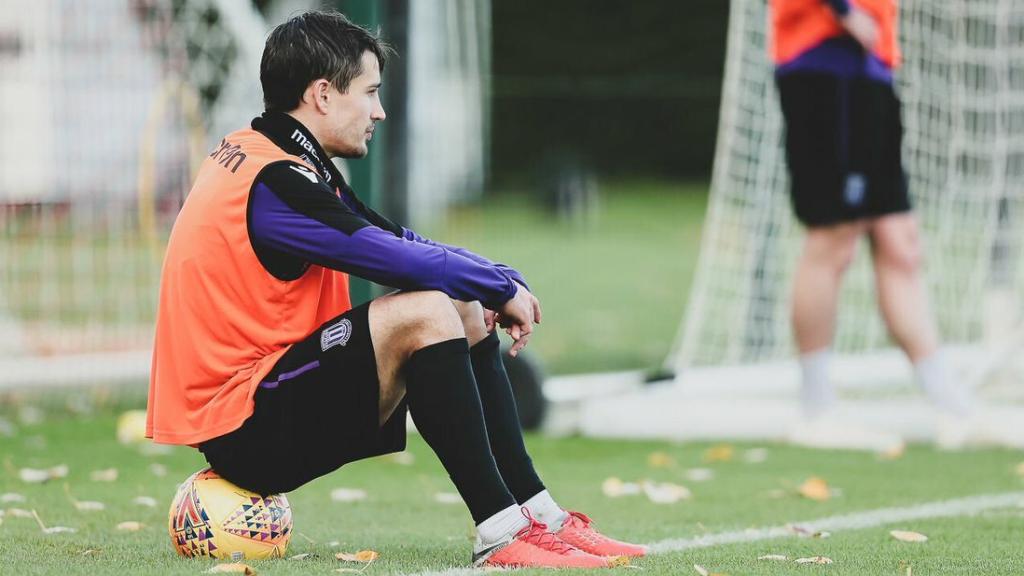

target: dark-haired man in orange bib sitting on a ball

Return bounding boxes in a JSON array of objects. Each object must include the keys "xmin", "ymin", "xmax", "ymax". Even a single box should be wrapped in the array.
[{"xmin": 146, "ymin": 11, "xmax": 644, "ymax": 568}]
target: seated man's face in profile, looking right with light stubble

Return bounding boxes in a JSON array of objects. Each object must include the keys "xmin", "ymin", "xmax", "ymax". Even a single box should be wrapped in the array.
[{"xmin": 322, "ymin": 50, "xmax": 385, "ymax": 158}]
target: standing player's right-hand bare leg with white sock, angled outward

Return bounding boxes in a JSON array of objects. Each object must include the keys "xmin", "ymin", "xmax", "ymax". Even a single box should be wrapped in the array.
[{"xmin": 870, "ymin": 212, "xmax": 971, "ymax": 416}]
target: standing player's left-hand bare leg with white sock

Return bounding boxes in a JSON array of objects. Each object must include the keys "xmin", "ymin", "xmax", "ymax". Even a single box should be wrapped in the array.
[{"xmin": 792, "ymin": 221, "xmax": 867, "ymax": 412}]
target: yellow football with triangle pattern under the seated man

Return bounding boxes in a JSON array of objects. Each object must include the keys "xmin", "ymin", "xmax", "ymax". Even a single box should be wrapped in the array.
[{"xmin": 168, "ymin": 468, "xmax": 292, "ymax": 561}]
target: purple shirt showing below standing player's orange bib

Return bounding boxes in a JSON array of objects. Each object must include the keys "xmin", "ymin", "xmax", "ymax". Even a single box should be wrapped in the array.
[{"xmin": 775, "ymin": 0, "xmax": 893, "ymax": 84}]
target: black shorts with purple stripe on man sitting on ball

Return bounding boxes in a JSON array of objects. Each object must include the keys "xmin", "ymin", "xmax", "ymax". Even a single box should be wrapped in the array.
[{"xmin": 199, "ymin": 303, "xmax": 406, "ymax": 495}]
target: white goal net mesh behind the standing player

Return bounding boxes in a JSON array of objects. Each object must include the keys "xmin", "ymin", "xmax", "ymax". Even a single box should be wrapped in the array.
[{"xmin": 669, "ymin": 0, "xmax": 1024, "ymax": 377}]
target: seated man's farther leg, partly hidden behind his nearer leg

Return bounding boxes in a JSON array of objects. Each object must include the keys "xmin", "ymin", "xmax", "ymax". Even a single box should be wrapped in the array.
[{"xmin": 453, "ymin": 300, "xmax": 646, "ymax": 557}]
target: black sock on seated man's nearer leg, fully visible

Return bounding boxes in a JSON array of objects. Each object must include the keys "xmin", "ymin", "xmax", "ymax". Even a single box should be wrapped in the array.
[{"xmin": 406, "ymin": 338, "xmax": 516, "ymax": 524}]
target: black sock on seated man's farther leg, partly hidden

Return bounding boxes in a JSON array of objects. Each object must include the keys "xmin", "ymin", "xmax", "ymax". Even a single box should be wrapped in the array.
[{"xmin": 469, "ymin": 332, "xmax": 544, "ymax": 503}]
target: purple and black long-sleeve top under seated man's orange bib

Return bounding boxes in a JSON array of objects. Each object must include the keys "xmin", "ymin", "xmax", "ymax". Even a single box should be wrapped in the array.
[{"xmin": 248, "ymin": 113, "xmax": 526, "ymax": 308}]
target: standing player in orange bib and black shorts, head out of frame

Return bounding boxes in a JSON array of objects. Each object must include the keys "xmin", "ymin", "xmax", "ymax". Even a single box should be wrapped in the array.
[{"xmin": 771, "ymin": 0, "xmax": 971, "ymax": 449}]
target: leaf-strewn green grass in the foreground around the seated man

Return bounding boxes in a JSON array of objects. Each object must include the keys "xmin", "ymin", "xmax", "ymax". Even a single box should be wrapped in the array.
[{"xmin": 0, "ymin": 404, "xmax": 1024, "ymax": 576}]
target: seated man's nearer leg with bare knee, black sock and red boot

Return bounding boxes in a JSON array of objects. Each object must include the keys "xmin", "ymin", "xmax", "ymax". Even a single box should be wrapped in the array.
[{"xmin": 369, "ymin": 292, "xmax": 607, "ymax": 568}]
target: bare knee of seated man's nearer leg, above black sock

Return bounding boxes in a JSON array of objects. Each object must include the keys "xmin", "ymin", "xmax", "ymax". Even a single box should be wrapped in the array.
[{"xmin": 370, "ymin": 291, "xmax": 466, "ymax": 353}]
